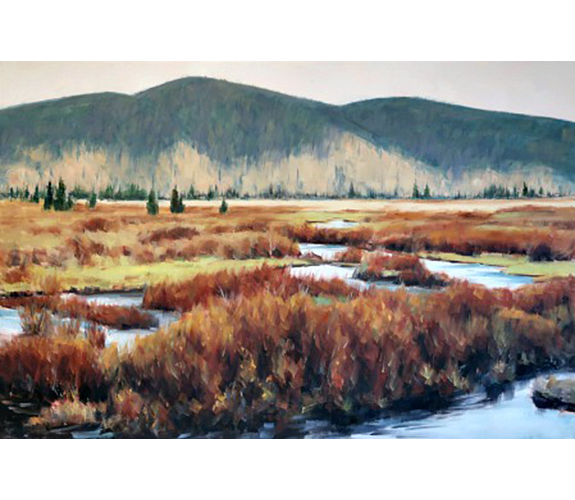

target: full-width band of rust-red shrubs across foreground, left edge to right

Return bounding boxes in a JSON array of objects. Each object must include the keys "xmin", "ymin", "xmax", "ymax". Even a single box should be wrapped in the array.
[{"xmin": 0, "ymin": 276, "xmax": 575, "ymax": 436}]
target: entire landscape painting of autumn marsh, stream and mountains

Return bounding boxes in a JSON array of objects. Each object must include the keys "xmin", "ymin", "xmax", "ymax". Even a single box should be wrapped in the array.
[{"xmin": 0, "ymin": 62, "xmax": 575, "ymax": 439}]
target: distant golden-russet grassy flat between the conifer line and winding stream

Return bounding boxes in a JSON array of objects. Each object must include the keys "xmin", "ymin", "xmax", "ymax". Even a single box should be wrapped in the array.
[{"xmin": 0, "ymin": 195, "xmax": 575, "ymax": 292}]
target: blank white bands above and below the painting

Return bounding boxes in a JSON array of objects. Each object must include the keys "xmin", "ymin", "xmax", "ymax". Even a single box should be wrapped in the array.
[{"xmin": 0, "ymin": 0, "xmax": 575, "ymax": 500}]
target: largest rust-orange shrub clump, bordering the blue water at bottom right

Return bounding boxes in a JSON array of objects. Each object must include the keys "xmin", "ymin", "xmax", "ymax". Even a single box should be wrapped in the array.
[{"xmin": 120, "ymin": 280, "xmax": 575, "ymax": 431}]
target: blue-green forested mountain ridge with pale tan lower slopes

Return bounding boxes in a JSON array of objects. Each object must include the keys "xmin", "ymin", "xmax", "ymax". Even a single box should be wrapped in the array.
[{"xmin": 0, "ymin": 78, "xmax": 575, "ymax": 196}]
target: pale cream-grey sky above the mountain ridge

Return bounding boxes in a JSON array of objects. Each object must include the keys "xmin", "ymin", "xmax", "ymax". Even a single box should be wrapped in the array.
[{"xmin": 0, "ymin": 62, "xmax": 575, "ymax": 121}]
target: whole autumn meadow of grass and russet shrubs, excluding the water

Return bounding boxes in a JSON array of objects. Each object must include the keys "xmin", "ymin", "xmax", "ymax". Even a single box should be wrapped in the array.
[{"xmin": 0, "ymin": 200, "xmax": 575, "ymax": 437}]
